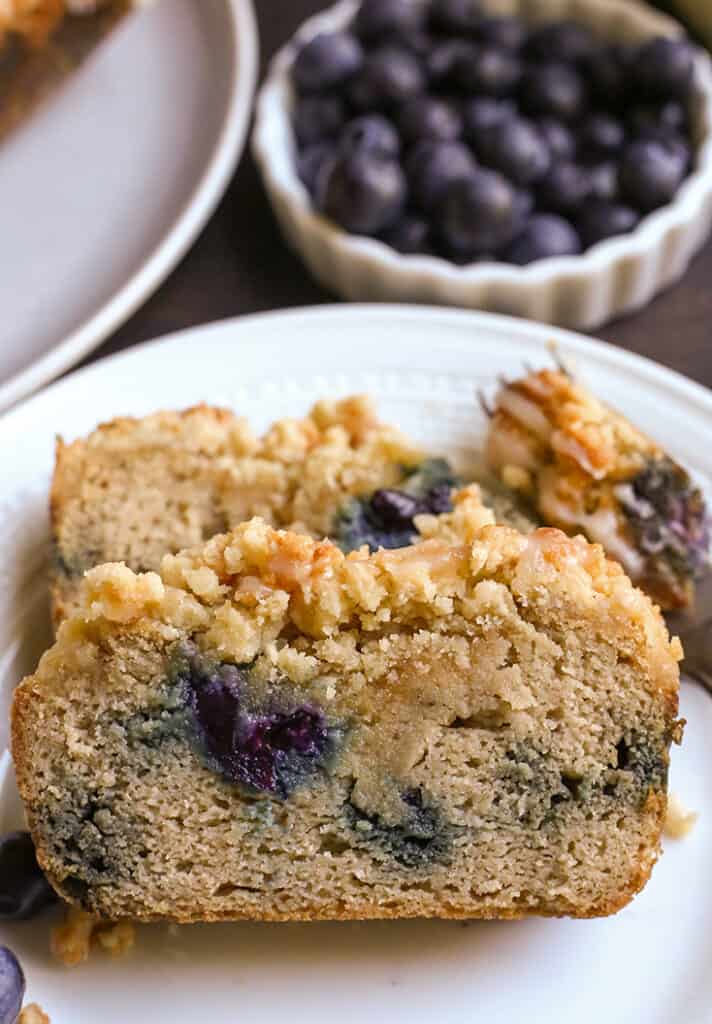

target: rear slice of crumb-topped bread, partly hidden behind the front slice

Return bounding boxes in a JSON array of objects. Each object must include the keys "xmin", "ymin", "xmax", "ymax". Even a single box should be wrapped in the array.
[{"xmin": 51, "ymin": 396, "xmax": 532, "ymax": 624}]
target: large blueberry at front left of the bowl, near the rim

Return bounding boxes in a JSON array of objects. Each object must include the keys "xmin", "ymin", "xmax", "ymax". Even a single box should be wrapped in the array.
[{"xmin": 319, "ymin": 152, "xmax": 407, "ymax": 234}]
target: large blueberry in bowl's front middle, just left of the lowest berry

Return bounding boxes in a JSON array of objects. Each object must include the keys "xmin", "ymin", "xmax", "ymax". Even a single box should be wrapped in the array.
[{"xmin": 441, "ymin": 170, "xmax": 522, "ymax": 257}]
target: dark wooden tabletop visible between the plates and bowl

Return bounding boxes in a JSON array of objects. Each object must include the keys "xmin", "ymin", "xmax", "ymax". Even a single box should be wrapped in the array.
[{"xmin": 88, "ymin": 0, "xmax": 712, "ymax": 387}]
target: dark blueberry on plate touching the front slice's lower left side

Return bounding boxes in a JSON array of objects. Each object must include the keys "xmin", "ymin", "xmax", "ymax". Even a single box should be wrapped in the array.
[{"xmin": 0, "ymin": 831, "xmax": 56, "ymax": 921}]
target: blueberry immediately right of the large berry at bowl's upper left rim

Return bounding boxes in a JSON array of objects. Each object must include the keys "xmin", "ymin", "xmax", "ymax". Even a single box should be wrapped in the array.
[{"xmin": 348, "ymin": 46, "xmax": 425, "ymax": 112}]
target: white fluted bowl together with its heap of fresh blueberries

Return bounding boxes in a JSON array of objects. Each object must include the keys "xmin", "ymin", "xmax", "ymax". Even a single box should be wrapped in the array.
[{"xmin": 253, "ymin": 0, "xmax": 712, "ymax": 328}]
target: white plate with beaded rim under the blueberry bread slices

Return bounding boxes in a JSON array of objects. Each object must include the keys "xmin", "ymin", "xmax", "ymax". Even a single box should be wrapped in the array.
[{"xmin": 0, "ymin": 306, "xmax": 712, "ymax": 1024}]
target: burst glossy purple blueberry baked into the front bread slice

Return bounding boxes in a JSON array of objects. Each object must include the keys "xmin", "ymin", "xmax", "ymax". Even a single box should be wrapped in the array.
[{"xmin": 179, "ymin": 651, "xmax": 333, "ymax": 798}]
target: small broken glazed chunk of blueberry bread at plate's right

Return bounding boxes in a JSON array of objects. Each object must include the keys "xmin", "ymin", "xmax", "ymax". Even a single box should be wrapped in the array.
[{"xmin": 487, "ymin": 370, "xmax": 709, "ymax": 609}]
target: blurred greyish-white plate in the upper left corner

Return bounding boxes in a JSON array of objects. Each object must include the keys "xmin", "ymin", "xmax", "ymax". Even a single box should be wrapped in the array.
[{"xmin": 0, "ymin": 0, "xmax": 257, "ymax": 409}]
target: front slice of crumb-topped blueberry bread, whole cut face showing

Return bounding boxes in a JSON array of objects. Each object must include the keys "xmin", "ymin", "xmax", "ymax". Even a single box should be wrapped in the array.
[{"xmin": 12, "ymin": 520, "xmax": 680, "ymax": 922}]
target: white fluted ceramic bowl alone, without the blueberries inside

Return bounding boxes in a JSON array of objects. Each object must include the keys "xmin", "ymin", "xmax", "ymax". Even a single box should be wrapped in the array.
[{"xmin": 252, "ymin": 0, "xmax": 712, "ymax": 328}]
